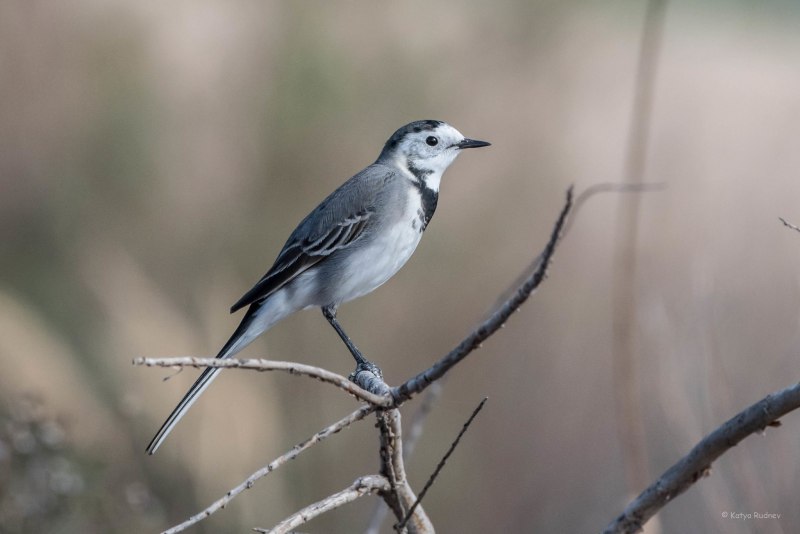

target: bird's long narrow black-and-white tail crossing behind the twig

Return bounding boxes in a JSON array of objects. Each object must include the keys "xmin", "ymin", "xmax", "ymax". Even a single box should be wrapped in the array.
[{"xmin": 147, "ymin": 303, "xmax": 264, "ymax": 454}]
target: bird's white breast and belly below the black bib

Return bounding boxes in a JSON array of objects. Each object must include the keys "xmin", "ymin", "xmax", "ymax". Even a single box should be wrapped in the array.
[{"xmin": 337, "ymin": 187, "xmax": 422, "ymax": 302}]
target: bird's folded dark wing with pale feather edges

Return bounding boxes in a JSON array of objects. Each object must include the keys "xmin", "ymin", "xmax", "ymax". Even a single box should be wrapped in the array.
[{"xmin": 231, "ymin": 209, "xmax": 373, "ymax": 313}]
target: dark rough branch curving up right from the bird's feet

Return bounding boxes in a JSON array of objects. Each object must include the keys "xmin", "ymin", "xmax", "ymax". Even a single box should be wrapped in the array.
[{"xmin": 392, "ymin": 187, "xmax": 573, "ymax": 405}]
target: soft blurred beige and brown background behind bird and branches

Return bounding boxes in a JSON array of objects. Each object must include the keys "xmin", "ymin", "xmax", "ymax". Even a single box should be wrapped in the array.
[{"xmin": 0, "ymin": 0, "xmax": 800, "ymax": 533}]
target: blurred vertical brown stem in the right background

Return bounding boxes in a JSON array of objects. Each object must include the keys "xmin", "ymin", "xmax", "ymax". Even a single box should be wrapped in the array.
[{"xmin": 612, "ymin": 0, "xmax": 666, "ymax": 491}]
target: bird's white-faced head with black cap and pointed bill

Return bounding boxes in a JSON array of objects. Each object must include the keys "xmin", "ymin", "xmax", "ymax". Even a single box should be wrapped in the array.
[{"xmin": 378, "ymin": 120, "xmax": 490, "ymax": 189}]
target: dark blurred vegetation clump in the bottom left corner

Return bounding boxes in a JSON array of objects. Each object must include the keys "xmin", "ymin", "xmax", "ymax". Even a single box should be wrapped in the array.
[{"xmin": 0, "ymin": 396, "xmax": 160, "ymax": 533}]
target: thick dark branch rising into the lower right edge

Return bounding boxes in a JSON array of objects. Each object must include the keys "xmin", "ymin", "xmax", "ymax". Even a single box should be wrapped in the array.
[{"xmin": 603, "ymin": 384, "xmax": 800, "ymax": 534}]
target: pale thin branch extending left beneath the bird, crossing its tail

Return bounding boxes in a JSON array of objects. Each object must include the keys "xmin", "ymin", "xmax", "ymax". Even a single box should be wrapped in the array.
[{"xmin": 133, "ymin": 356, "xmax": 392, "ymax": 407}]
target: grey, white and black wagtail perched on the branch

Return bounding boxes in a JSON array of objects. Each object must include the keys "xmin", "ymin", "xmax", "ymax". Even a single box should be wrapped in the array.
[{"xmin": 146, "ymin": 119, "xmax": 490, "ymax": 454}]
